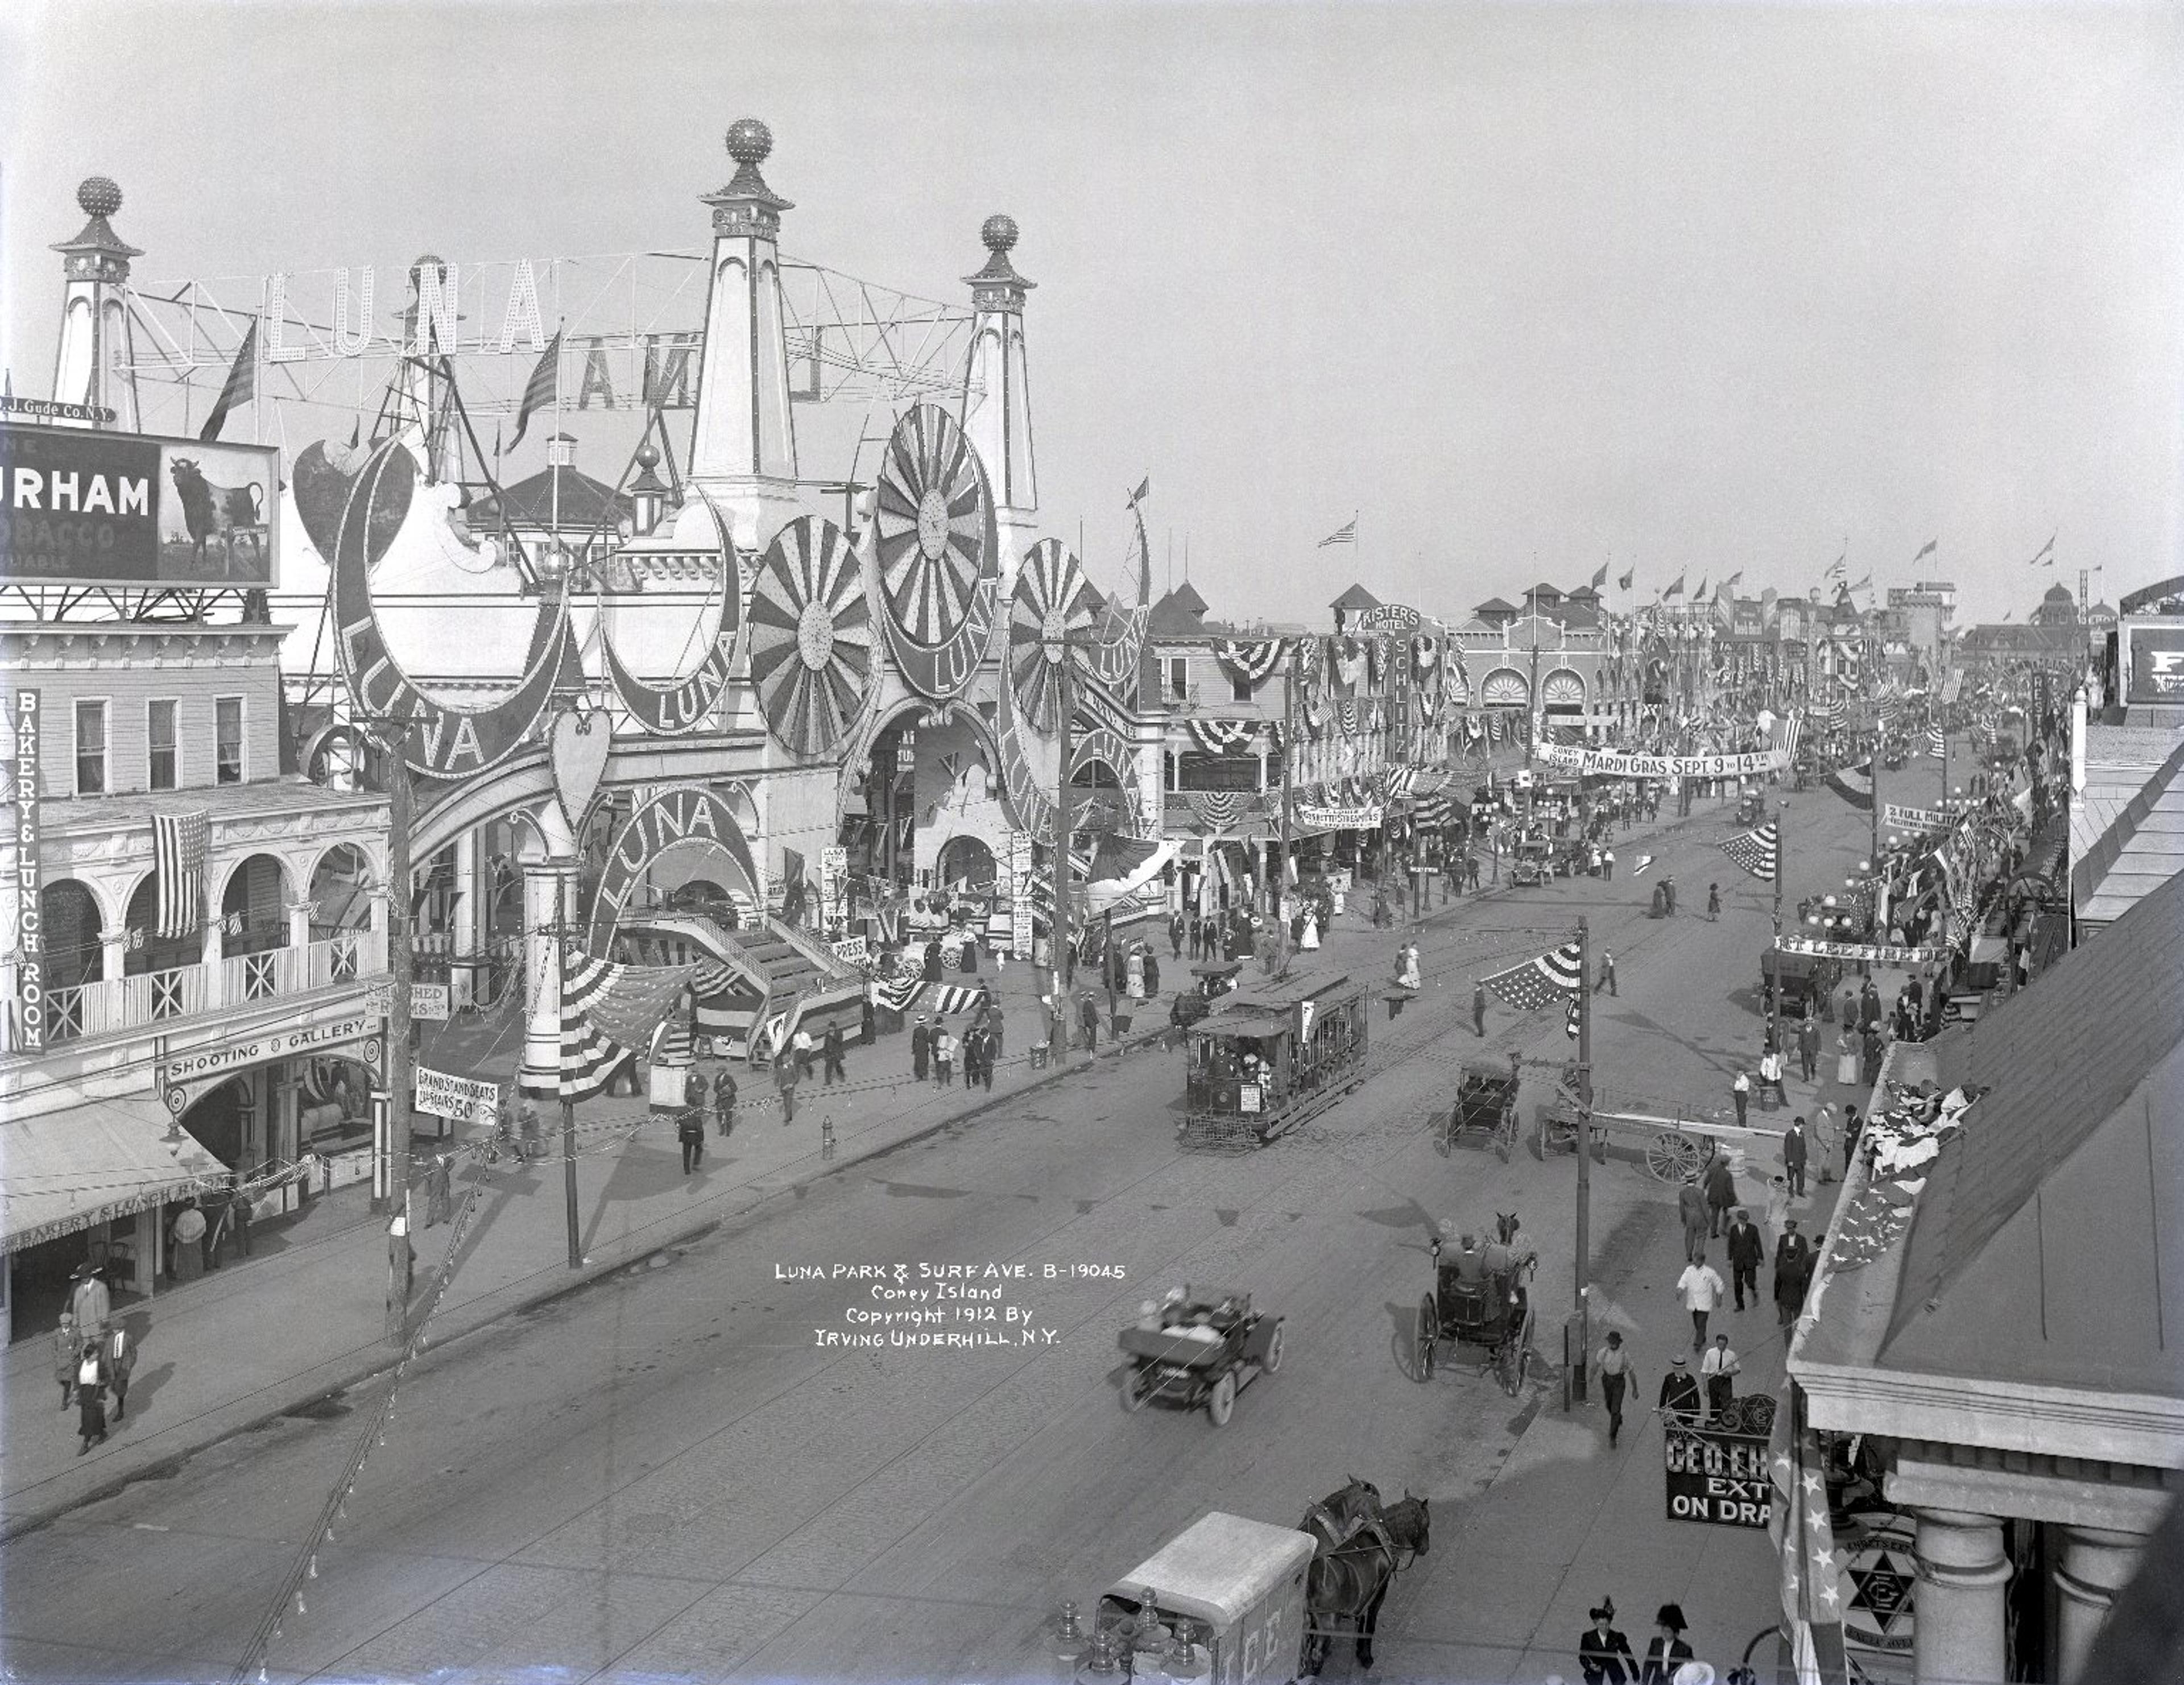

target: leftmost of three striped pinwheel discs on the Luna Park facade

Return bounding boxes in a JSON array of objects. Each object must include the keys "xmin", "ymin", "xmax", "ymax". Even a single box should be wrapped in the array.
[{"xmin": 751, "ymin": 515, "xmax": 871, "ymax": 760}]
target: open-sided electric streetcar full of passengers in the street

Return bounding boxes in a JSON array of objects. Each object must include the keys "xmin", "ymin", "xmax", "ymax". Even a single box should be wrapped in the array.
[{"xmin": 1177, "ymin": 971, "xmax": 1365, "ymax": 1150}]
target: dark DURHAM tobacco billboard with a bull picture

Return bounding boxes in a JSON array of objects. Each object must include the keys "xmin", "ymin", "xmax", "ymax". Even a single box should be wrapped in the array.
[{"xmin": 0, "ymin": 419, "xmax": 280, "ymax": 587}]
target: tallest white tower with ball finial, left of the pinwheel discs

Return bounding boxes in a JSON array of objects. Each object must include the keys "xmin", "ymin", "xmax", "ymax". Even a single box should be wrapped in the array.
[{"xmin": 690, "ymin": 118, "xmax": 804, "ymax": 550}]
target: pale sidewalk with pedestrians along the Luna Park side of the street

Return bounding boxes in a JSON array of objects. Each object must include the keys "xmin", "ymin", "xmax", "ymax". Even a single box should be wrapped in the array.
[{"xmin": 0, "ymin": 947, "xmax": 1144, "ymax": 1539}]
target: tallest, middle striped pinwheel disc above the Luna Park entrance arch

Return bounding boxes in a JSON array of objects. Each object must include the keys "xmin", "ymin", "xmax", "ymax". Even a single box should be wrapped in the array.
[{"xmin": 874, "ymin": 404, "xmax": 1000, "ymax": 701}]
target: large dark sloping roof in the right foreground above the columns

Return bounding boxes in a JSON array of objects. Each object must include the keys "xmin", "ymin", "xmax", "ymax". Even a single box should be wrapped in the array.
[{"xmin": 1878, "ymin": 855, "xmax": 2184, "ymax": 1397}]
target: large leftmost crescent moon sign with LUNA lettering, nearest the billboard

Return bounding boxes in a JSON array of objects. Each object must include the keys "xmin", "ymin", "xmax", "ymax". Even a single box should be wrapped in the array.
[{"xmin": 334, "ymin": 438, "xmax": 583, "ymax": 779}]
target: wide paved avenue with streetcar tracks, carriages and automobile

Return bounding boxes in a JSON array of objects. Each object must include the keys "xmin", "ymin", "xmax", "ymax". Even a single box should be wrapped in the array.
[{"xmin": 0, "ymin": 775, "xmax": 1896, "ymax": 1680}]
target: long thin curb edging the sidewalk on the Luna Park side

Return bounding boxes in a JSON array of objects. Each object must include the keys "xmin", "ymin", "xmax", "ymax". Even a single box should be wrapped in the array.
[{"xmin": 0, "ymin": 1024, "xmax": 1168, "ymax": 1545}]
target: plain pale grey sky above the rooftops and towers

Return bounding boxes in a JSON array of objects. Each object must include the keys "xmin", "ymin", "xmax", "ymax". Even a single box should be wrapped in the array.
[{"xmin": 0, "ymin": 0, "xmax": 2184, "ymax": 624}]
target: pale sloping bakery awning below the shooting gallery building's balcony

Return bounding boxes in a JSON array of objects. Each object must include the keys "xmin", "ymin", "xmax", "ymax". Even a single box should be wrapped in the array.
[{"xmin": 0, "ymin": 1098, "xmax": 229, "ymax": 1253}]
